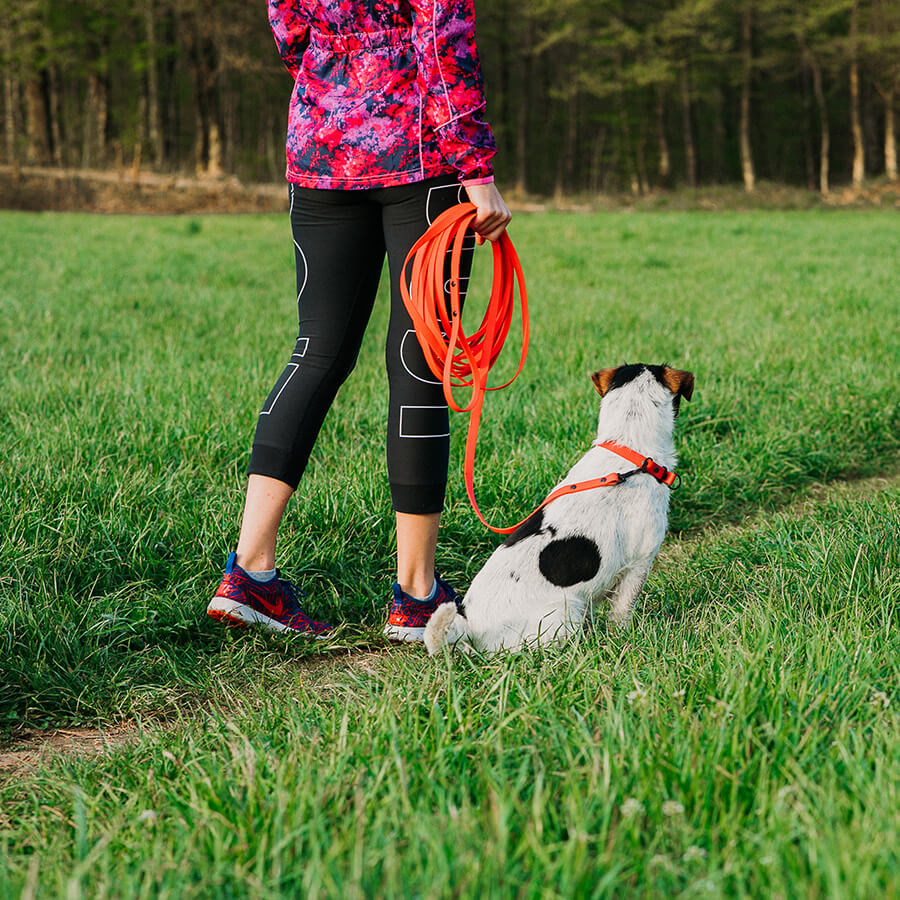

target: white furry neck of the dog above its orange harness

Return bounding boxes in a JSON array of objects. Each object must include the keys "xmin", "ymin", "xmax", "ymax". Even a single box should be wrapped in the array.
[{"xmin": 597, "ymin": 389, "xmax": 676, "ymax": 468}]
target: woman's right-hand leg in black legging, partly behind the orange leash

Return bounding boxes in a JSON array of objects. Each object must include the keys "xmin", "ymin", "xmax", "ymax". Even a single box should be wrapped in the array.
[{"xmin": 377, "ymin": 177, "xmax": 474, "ymax": 597}]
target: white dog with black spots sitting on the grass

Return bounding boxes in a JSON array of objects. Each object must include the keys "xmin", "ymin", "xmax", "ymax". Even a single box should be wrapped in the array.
[{"xmin": 425, "ymin": 364, "xmax": 694, "ymax": 654}]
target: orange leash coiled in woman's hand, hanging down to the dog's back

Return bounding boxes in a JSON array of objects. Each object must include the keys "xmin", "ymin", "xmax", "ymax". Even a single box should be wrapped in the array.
[{"xmin": 400, "ymin": 203, "xmax": 528, "ymax": 534}]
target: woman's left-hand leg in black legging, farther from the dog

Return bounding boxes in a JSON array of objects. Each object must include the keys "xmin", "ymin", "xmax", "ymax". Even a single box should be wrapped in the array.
[{"xmin": 237, "ymin": 185, "xmax": 384, "ymax": 570}]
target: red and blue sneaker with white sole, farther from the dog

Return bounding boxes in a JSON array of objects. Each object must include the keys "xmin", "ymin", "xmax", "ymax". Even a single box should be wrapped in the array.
[{"xmin": 206, "ymin": 553, "xmax": 331, "ymax": 637}]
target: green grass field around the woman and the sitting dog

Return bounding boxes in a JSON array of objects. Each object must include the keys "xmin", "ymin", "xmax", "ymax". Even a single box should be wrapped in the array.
[{"xmin": 0, "ymin": 211, "xmax": 900, "ymax": 898}]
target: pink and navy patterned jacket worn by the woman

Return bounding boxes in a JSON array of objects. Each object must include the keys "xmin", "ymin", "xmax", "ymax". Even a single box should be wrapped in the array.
[{"xmin": 268, "ymin": 0, "xmax": 496, "ymax": 190}]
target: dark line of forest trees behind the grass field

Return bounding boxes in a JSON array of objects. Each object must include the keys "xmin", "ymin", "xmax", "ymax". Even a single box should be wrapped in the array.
[{"xmin": 0, "ymin": 0, "xmax": 900, "ymax": 194}]
